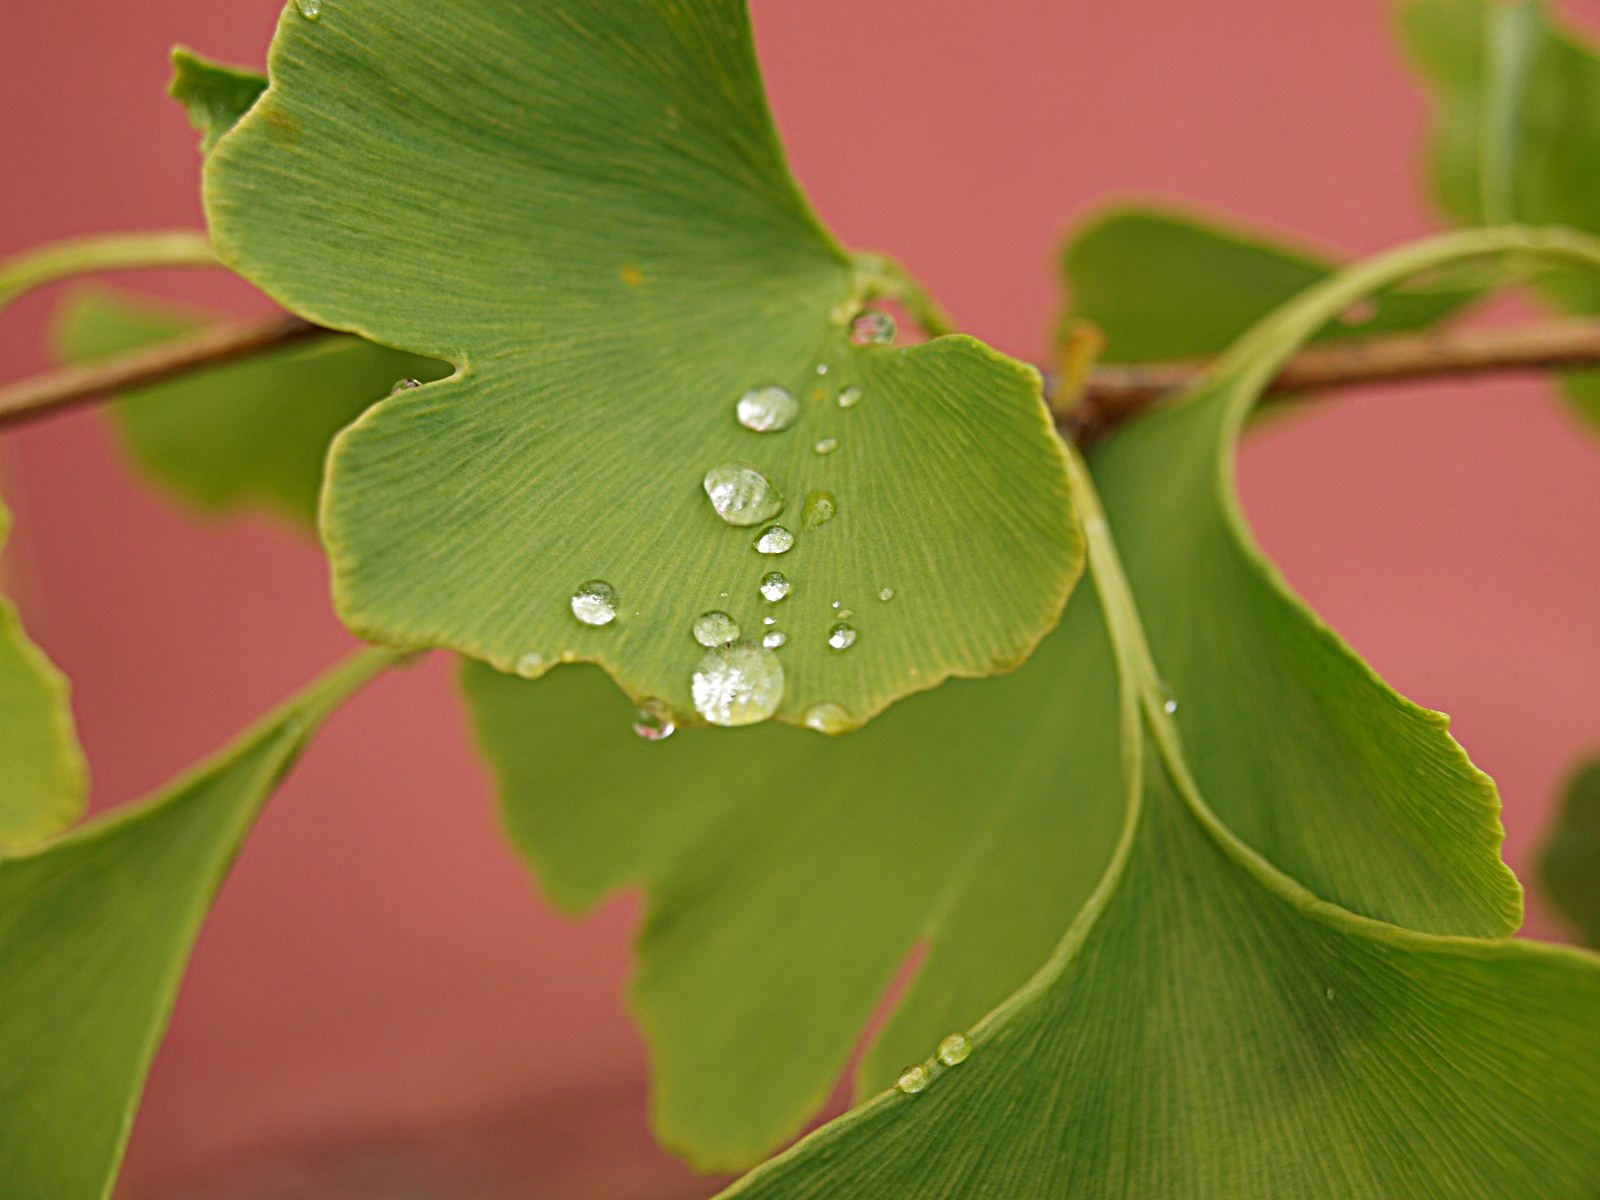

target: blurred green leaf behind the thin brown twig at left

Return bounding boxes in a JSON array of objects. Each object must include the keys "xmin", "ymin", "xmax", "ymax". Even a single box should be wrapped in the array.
[{"xmin": 56, "ymin": 293, "xmax": 450, "ymax": 528}]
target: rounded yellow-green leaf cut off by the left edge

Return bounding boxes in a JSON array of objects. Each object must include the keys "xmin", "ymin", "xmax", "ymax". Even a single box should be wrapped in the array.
[{"xmin": 0, "ymin": 504, "xmax": 88, "ymax": 850}]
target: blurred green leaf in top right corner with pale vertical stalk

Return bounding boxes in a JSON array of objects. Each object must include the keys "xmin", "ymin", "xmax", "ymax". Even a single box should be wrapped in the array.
[{"xmin": 1400, "ymin": 0, "xmax": 1600, "ymax": 426}]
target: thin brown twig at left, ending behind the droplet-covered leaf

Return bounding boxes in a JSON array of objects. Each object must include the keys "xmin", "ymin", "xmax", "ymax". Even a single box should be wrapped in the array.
[{"xmin": 0, "ymin": 314, "xmax": 328, "ymax": 426}]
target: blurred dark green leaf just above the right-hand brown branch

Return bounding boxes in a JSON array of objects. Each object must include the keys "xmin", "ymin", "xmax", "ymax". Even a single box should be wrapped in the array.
[{"xmin": 1061, "ymin": 205, "xmax": 1478, "ymax": 362}]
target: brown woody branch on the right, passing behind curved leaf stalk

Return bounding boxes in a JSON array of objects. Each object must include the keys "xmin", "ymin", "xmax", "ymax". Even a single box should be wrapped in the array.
[{"xmin": 1051, "ymin": 318, "xmax": 1600, "ymax": 442}]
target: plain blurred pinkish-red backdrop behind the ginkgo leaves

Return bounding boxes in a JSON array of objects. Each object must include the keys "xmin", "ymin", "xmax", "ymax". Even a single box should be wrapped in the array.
[{"xmin": 0, "ymin": 0, "xmax": 1600, "ymax": 1197}]
